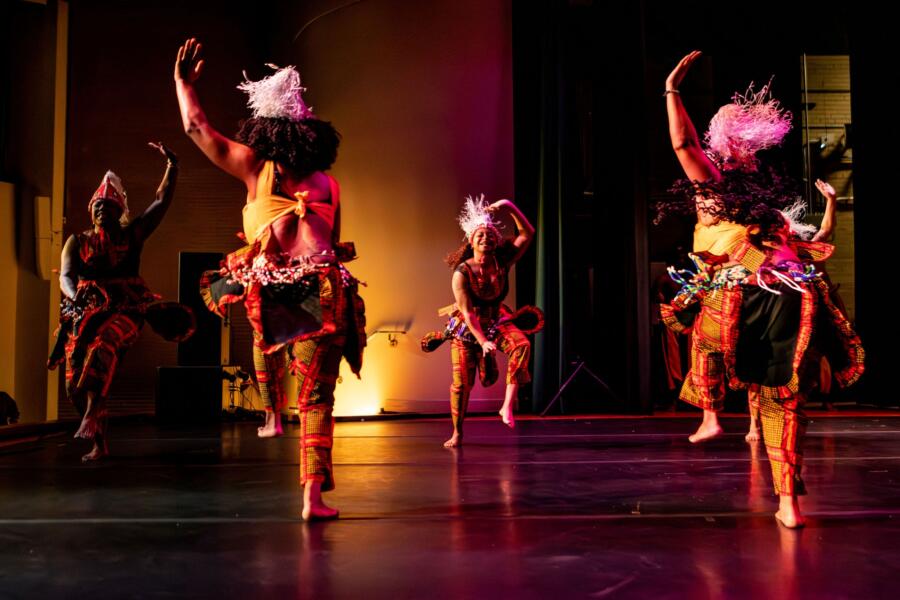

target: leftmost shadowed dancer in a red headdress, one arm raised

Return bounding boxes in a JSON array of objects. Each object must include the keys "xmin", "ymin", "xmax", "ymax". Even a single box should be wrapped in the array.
[{"xmin": 48, "ymin": 143, "xmax": 194, "ymax": 462}]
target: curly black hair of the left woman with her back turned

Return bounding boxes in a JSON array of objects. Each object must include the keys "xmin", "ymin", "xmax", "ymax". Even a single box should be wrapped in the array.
[{"xmin": 235, "ymin": 117, "xmax": 341, "ymax": 177}]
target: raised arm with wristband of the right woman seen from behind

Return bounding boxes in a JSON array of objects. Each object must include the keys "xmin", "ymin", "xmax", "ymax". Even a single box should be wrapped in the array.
[{"xmin": 665, "ymin": 50, "xmax": 722, "ymax": 186}]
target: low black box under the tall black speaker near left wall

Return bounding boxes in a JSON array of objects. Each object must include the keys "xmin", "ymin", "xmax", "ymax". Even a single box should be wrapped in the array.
[{"xmin": 156, "ymin": 367, "xmax": 222, "ymax": 425}]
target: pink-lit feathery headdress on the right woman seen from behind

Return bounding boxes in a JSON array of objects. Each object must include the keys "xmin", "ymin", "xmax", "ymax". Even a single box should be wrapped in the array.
[{"xmin": 704, "ymin": 80, "xmax": 793, "ymax": 171}]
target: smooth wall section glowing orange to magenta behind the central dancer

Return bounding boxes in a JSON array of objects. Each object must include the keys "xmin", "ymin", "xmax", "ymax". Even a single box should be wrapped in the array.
[{"xmin": 282, "ymin": 0, "xmax": 513, "ymax": 415}]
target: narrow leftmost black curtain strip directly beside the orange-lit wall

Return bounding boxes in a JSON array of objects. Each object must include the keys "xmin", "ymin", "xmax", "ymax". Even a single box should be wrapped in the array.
[{"xmin": 513, "ymin": 0, "xmax": 570, "ymax": 410}]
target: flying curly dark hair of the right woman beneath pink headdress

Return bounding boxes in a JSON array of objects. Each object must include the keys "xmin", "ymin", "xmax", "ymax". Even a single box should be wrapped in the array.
[{"xmin": 654, "ymin": 168, "xmax": 799, "ymax": 239}]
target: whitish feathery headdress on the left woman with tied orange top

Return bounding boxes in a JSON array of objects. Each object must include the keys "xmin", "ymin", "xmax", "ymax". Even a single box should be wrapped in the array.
[{"xmin": 237, "ymin": 63, "xmax": 315, "ymax": 121}]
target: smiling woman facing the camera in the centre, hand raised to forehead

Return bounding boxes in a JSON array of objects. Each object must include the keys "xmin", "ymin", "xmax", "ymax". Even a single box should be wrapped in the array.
[{"xmin": 423, "ymin": 196, "xmax": 536, "ymax": 448}]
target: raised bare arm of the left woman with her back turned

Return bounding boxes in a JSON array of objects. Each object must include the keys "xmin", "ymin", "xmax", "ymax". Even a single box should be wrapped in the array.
[{"xmin": 175, "ymin": 38, "xmax": 260, "ymax": 183}]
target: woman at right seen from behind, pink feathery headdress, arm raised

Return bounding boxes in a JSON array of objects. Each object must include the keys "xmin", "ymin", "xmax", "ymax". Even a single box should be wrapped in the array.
[{"xmin": 660, "ymin": 52, "xmax": 862, "ymax": 527}]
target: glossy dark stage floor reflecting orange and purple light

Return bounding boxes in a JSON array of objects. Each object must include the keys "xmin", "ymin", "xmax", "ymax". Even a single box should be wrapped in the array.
[{"xmin": 0, "ymin": 415, "xmax": 900, "ymax": 600}]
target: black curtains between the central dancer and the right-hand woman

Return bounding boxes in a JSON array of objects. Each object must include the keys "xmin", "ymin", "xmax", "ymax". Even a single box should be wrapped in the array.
[{"xmin": 513, "ymin": 0, "xmax": 650, "ymax": 412}]
